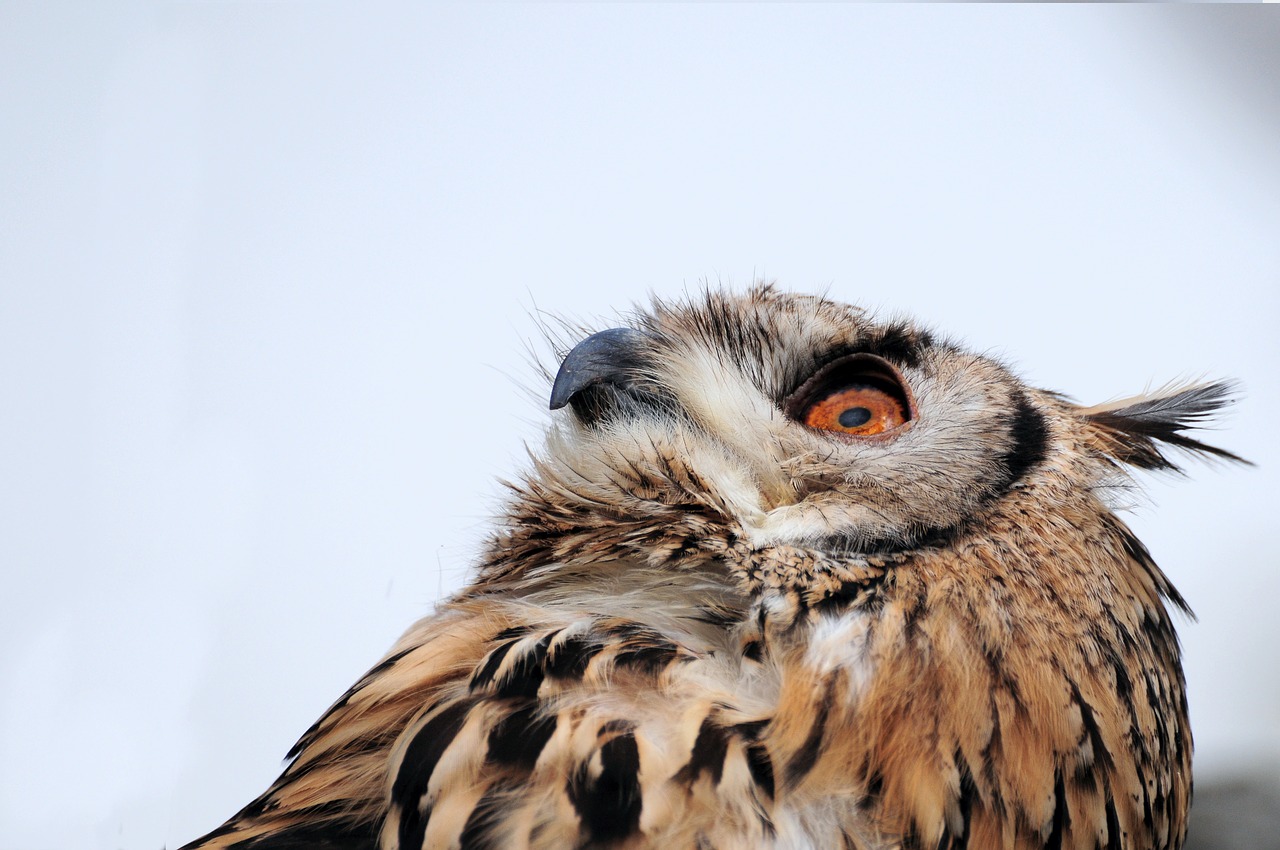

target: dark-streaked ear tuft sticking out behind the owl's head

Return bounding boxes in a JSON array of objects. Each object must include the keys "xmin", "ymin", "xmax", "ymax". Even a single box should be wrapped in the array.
[{"xmin": 1080, "ymin": 380, "xmax": 1252, "ymax": 471}]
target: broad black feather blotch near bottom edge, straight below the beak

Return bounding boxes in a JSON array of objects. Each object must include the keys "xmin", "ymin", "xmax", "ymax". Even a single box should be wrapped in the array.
[{"xmin": 566, "ymin": 734, "xmax": 644, "ymax": 842}]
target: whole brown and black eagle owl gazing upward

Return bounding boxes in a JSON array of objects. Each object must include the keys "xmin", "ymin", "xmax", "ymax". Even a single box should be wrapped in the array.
[{"xmin": 187, "ymin": 287, "xmax": 1238, "ymax": 850}]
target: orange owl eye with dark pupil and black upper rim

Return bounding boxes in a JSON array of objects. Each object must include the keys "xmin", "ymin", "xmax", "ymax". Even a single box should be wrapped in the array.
[{"xmin": 786, "ymin": 355, "xmax": 911, "ymax": 437}]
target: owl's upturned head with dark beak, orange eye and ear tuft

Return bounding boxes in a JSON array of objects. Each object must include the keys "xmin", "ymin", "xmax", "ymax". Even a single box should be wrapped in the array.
[{"xmin": 496, "ymin": 285, "xmax": 1234, "ymax": 578}]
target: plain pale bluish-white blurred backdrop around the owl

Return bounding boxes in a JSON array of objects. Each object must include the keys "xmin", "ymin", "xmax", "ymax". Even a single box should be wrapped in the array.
[{"xmin": 0, "ymin": 3, "xmax": 1280, "ymax": 850}]
